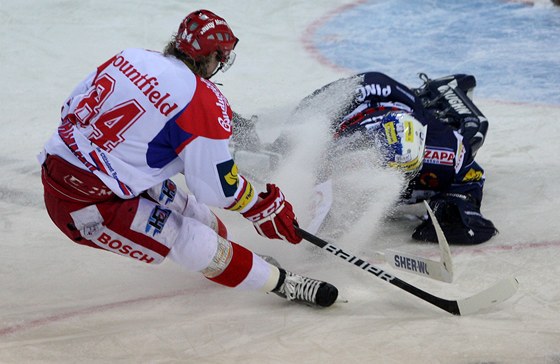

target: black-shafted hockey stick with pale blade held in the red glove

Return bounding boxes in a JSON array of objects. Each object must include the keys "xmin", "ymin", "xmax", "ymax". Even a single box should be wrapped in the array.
[{"xmin": 295, "ymin": 226, "xmax": 519, "ymax": 316}]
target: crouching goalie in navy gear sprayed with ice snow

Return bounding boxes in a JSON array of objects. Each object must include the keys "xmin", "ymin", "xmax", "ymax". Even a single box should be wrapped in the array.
[{"xmin": 234, "ymin": 72, "xmax": 497, "ymax": 244}]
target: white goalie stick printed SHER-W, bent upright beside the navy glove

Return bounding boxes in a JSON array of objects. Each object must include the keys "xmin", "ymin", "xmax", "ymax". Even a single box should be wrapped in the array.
[{"xmin": 377, "ymin": 201, "xmax": 453, "ymax": 283}]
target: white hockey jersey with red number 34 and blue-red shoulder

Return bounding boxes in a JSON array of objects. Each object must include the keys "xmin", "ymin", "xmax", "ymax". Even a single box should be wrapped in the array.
[{"xmin": 40, "ymin": 49, "xmax": 257, "ymax": 212}]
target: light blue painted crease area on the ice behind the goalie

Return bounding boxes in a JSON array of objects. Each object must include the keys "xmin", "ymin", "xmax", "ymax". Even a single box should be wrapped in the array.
[{"xmin": 308, "ymin": 0, "xmax": 560, "ymax": 104}]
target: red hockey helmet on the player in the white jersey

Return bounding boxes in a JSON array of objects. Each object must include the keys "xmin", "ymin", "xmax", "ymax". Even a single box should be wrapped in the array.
[{"xmin": 175, "ymin": 9, "xmax": 239, "ymax": 64}]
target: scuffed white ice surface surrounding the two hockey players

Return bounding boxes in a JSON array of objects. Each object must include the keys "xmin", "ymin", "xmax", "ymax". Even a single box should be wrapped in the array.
[{"xmin": 0, "ymin": 0, "xmax": 560, "ymax": 364}]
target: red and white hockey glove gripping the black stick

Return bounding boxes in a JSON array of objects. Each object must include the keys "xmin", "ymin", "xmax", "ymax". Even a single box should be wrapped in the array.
[{"xmin": 243, "ymin": 184, "xmax": 301, "ymax": 244}]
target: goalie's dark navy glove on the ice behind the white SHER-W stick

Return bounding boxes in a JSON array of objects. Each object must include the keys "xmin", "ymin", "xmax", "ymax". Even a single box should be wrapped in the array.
[{"xmin": 412, "ymin": 193, "xmax": 498, "ymax": 245}]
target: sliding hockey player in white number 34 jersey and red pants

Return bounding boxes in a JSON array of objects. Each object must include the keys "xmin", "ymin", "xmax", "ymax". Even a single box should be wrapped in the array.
[{"xmin": 39, "ymin": 10, "xmax": 338, "ymax": 307}]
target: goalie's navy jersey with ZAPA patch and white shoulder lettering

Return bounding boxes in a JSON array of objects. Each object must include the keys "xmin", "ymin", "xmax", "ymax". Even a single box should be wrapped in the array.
[{"xmin": 316, "ymin": 72, "xmax": 484, "ymax": 204}]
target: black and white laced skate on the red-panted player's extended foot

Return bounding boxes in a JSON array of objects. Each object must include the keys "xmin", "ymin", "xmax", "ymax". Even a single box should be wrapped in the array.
[{"xmin": 272, "ymin": 268, "xmax": 338, "ymax": 307}]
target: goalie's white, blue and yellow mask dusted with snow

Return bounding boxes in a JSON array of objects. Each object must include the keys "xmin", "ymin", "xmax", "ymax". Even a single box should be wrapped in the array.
[{"xmin": 375, "ymin": 112, "xmax": 428, "ymax": 178}]
